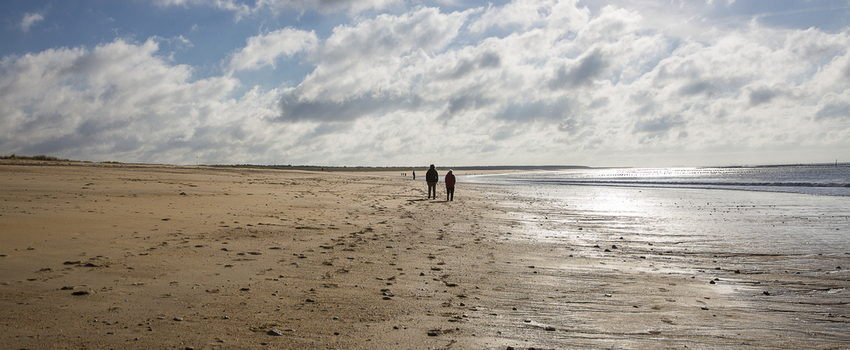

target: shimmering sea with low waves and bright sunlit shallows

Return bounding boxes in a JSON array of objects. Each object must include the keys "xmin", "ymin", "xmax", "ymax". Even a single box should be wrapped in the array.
[{"xmin": 455, "ymin": 163, "xmax": 850, "ymax": 258}]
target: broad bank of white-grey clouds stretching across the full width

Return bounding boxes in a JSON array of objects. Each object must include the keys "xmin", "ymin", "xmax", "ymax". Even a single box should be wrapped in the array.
[{"xmin": 0, "ymin": 0, "xmax": 850, "ymax": 165}]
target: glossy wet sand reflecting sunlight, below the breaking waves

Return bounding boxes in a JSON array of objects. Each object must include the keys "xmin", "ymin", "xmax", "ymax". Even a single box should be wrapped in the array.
[{"xmin": 490, "ymin": 186, "xmax": 850, "ymax": 348}]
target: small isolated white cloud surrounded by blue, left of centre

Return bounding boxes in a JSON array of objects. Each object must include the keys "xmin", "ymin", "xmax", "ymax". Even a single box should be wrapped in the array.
[{"xmin": 229, "ymin": 28, "xmax": 318, "ymax": 71}]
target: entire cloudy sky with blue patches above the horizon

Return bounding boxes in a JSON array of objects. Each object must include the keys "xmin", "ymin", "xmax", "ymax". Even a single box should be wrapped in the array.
[{"xmin": 0, "ymin": 0, "xmax": 850, "ymax": 167}]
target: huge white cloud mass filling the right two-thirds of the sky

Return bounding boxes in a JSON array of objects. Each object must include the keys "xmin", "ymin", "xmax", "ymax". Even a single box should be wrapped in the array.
[{"xmin": 268, "ymin": 1, "xmax": 850, "ymax": 164}]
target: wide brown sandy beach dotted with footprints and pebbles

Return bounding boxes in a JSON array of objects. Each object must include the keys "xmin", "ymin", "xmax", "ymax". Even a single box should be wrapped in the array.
[{"xmin": 0, "ymin": 161, "xmax": 850, "ymax": 349}]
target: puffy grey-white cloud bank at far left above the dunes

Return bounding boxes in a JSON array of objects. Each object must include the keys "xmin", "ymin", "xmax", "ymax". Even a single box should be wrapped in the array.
[{"xmin": 0, "ymin": 40, "xmax": 278, "ymax": 162}]
